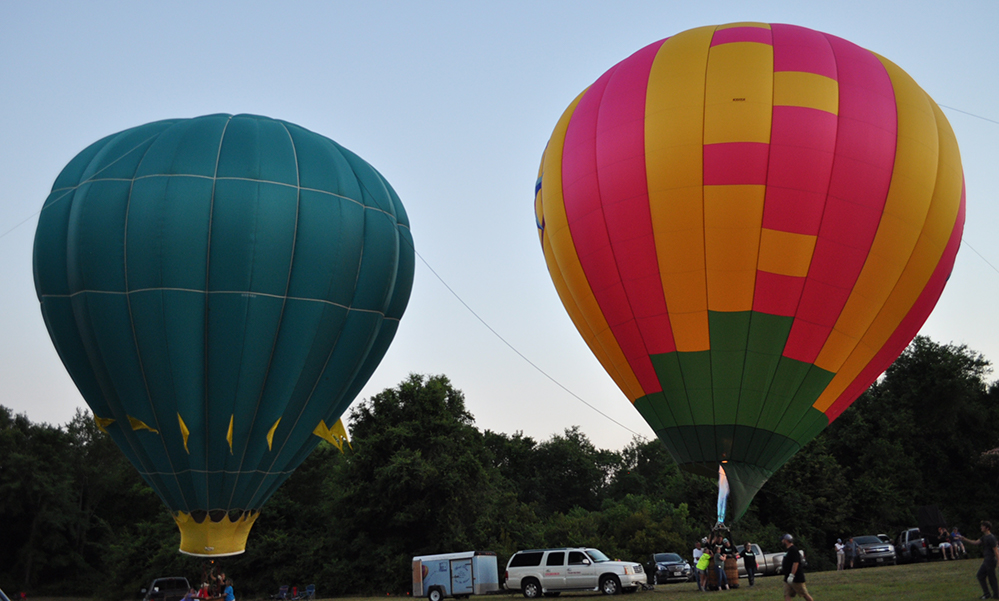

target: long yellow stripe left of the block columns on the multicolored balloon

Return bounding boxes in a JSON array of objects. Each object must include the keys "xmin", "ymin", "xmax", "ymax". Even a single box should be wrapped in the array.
[{"xmin": 645, "ymin": 27, "xmax": 715, "ymax": 352}]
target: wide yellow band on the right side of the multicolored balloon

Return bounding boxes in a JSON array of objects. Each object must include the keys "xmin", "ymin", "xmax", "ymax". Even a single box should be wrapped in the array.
[{"xmin": 814, "ymin": 57, "xmax": 963, "ymax": 411}]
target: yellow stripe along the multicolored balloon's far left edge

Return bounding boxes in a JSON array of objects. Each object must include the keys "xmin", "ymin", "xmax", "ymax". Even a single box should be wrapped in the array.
[{"xmin": 541, "ymin": 90, "xmax": 645, "ymax": 402}]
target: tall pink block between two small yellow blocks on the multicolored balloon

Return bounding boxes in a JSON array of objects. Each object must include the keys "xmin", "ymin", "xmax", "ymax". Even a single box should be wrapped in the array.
[{"xmin": 763, "ymin": 106, "xmax": 836, "ymax": 236}]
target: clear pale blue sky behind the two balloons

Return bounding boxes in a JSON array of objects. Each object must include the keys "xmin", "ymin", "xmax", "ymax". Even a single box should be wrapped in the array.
[{"xmin": 0, "ymin": 0, "xmax": 999, "ymax": 449}]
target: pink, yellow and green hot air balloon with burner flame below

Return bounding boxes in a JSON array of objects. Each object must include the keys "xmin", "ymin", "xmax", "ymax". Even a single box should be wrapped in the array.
[{"xmin": 535, "ymin": 23, "xmax": 964, "ymax": 519}]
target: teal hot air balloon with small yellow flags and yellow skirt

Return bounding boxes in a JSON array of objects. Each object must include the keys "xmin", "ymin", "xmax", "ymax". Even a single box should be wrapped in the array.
[{"xmin": 34, "ymin": 115, "xmax": 414, "ymax": 555}]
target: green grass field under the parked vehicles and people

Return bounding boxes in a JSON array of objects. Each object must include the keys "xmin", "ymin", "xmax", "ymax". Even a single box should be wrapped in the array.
[{"xmin": 31, "ymin": 559, "xmax": 996, "ymax": 601}]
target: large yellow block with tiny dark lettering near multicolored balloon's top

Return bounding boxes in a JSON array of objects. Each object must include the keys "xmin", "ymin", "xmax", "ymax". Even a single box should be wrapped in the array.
[{"xmin": 704, "ymin": 42, "xmax": 774, "ymax": 144}]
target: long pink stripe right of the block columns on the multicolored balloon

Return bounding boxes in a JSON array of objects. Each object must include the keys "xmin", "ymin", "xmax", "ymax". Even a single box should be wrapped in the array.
[{"xmin": 784, "ymin": 34, "xmax": 897, "ymax": 363}]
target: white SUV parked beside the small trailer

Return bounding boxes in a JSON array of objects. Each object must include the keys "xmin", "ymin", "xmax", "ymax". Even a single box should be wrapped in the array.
[{"xmin": 503, "ymin": 547, "xmax": 645, "ymax": 599}]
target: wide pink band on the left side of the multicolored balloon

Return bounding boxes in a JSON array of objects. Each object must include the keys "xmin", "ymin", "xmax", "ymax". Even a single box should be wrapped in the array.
[{"xmin": 562, "ymin": 41, "xmax": 676, "ymax": 394}]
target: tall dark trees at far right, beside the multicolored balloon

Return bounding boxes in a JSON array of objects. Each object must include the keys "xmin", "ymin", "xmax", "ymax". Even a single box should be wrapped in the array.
[{"xmin": 817, "ymin": 336, "xmax": 999, "ymax": 533}]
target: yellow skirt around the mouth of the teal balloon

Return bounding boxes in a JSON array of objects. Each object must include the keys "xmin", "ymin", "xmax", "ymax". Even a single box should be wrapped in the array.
[{"xmin": 173, "ymin": 509, "xmax": 260, "ymax": 557}]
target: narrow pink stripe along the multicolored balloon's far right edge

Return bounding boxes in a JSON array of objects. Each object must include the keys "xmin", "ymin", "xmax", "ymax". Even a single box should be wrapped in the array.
[{"xmin": 826, "ymin": 183, "xmax": 965, "ymax": 423}]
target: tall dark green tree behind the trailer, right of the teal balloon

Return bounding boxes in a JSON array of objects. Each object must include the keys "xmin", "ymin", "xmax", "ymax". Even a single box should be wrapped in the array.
[{"xmin": 323, "ymin": 374, "xmax": 508, "ymax": 593}]
